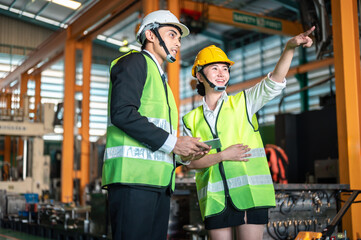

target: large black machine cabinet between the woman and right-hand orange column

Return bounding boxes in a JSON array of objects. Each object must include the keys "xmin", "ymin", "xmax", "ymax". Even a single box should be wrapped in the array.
[{"xmin": 275, "ymin": 75, "xmax": 339, "ymax": 183}]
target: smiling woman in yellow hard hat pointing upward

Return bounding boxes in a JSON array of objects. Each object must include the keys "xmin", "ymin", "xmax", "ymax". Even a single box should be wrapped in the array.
[{"xmin": 183, "ymin": 27, "xmax": 314, "ymax": 240}]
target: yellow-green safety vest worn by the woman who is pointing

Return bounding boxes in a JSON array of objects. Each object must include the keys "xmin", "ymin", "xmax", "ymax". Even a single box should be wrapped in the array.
[{"xmin": 183, "ymin": 91, "xmax": 275, "ymax": 219}]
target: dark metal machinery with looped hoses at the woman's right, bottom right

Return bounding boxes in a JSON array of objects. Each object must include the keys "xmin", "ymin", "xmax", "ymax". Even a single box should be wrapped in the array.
[{"xmin": 264, "ymin": 184, "xmax": 349, "ymax": 240}]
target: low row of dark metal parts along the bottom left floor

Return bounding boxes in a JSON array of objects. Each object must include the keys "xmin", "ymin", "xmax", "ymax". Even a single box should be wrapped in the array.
[{"xmin": 0, "ymin": 190, "xmax": 101, "ymax": 240}]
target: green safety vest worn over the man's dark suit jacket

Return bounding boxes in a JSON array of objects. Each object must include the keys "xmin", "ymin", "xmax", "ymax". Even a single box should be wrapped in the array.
[{"xmin": 102, "ymin": 51, "xmax": 178, "ymax": 189}]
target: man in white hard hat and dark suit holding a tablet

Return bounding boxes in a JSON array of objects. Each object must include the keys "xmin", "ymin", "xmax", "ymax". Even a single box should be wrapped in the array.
[{"xmin": 102, "ymin": 10, "xmax": 209, "ymax": 240}]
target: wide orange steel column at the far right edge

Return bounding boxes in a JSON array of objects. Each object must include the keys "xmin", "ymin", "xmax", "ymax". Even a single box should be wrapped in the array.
[{"xmin": 331, "ymin": 0, "xmax": 361, "ymax": 236}]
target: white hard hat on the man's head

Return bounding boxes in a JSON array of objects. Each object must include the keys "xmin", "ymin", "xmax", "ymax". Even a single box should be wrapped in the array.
[{"xmin": 136, "ymin": 10, "xmax": 189, "ymax": 44}]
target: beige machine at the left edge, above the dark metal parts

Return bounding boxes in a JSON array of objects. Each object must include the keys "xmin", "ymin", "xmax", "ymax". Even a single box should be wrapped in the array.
[{"xmin": 0, "ymin": 95, "xmax": 54, "ymax": 195}]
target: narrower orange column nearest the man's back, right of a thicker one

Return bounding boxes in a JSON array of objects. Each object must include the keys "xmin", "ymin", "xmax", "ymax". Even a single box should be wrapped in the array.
[{"xmin": 80, "ymin": 39, "xmax": 92, "ymax": 204}]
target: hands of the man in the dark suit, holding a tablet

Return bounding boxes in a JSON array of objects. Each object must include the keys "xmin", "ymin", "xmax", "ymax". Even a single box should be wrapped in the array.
[{"xmin": 173, "ymin": 136, "xmax": 211, "ymax": 161}]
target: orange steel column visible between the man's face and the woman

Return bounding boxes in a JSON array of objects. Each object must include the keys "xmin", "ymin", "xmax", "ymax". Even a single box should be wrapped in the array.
[{"xmin": 168, "ymin": 0, "xmax": 181, "ymax": 135}]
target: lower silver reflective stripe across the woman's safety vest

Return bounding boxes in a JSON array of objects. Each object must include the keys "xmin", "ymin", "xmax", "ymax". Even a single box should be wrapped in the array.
[{"xmin": 197, "ymin": 175, "xmax": 273, "ymax": 200}]
